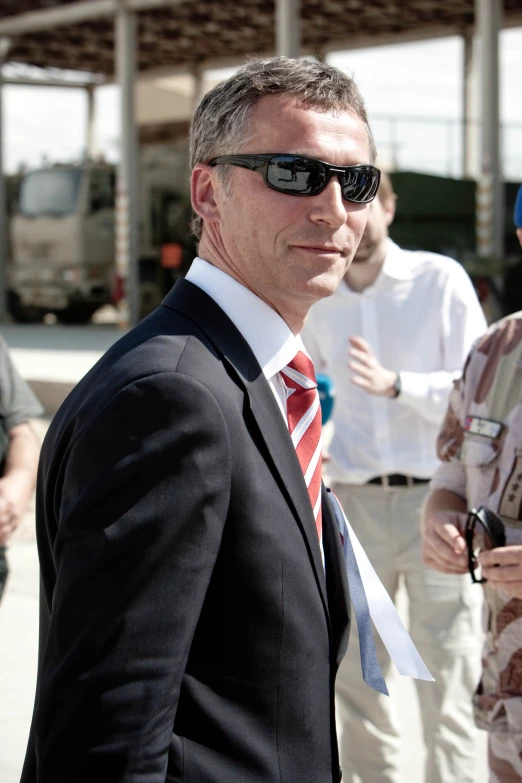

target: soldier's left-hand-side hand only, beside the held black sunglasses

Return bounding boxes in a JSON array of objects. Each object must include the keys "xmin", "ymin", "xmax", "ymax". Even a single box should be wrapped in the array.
[{"xmin": 422, "ymin": 511, "xmax": 468, "ymax": 574}]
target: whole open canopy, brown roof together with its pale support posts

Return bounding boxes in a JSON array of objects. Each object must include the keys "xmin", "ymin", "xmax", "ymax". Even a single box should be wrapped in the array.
[{"xmin": 0, "ymin": 0, "xmax": 512, "ymax": 323}]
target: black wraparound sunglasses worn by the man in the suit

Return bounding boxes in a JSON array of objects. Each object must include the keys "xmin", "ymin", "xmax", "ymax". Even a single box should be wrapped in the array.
[{"xmin": 209, "ymin": 153, "xmax": 381, "ymax": 204}]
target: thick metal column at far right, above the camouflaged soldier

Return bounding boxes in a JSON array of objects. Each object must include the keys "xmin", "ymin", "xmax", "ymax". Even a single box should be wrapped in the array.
[{"xmin": 475, "ymin": 0, "xmax": 504, "ymax": 259}]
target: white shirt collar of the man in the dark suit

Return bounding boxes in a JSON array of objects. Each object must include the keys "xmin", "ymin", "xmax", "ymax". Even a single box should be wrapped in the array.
[{"xmin": 185, "ymin": 257, "xmax": 302, "ymax": 380}]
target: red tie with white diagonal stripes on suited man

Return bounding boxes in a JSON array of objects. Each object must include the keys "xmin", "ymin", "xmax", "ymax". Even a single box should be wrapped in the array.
[{"xmin": 281, "ymin": 351, "xmax": 323, "ymax": 540}]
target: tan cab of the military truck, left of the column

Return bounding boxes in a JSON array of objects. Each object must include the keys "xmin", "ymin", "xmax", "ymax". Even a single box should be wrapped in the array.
[{"xmin": 9, "ymin": 164, "xmax": 115, "ymax": 323}]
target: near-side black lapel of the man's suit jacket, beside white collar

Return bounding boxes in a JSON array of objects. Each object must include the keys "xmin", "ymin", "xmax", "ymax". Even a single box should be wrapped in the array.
[{"xmin": 163, "ymin": 280, "xmax": 329, "ymax": 618}]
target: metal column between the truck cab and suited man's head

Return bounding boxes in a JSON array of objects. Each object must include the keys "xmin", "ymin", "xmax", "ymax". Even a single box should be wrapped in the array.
[{"xmin": 115, "ymin": 5, "xmax": 140, "ymax": 326}]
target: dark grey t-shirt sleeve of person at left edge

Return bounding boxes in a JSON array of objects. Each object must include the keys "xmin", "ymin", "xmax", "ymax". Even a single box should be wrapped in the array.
[{"xmin": 0, "ymin": 337, "xmax": 44, "ymax": 432}]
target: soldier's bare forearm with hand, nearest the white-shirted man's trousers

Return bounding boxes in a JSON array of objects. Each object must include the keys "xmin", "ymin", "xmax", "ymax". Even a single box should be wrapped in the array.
[{"xmin": 422, "ymin": 489, "xmax": 468, "ymax": 574}]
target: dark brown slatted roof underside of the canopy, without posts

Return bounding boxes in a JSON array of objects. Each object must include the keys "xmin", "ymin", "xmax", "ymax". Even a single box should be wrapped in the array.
[{"xmin": 0, "ymin": 0, "xmax": 522, "ymax": 77}]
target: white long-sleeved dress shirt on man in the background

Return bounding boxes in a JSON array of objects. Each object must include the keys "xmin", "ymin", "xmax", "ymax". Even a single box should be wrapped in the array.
[{"xmin": 302, "ymin": 240, "xmax": 487, "ymax": 484}]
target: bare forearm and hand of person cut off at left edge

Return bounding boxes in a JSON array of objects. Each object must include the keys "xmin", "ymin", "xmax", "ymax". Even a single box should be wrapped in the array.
[{"xmin": 0, "ymin": 422, "xmax": 40, "ymax": 545}]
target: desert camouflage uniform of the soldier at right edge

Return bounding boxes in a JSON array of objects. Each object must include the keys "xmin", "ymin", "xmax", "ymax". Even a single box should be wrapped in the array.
[{"xmin": 432, "ymin": 311, "xmax": 522, "ymax": 783}]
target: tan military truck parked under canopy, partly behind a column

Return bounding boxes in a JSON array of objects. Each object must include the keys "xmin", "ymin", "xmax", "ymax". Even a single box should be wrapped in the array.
[{"xmin": 8, "ymin": 142, "xmax": 194, "ymax": 324}]
